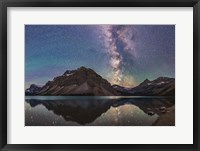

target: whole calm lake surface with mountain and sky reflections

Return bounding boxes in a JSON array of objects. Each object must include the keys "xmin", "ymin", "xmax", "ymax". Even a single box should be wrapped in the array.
[{"xmin": 25, "ymin": 96, "xmax": 175, "ymax": 126}]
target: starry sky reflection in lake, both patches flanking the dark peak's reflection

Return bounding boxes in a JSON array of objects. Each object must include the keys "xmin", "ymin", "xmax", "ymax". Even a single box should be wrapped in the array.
[{"xmin": 26, "ymin": 104, "xmax": 157, "ymax": 126}]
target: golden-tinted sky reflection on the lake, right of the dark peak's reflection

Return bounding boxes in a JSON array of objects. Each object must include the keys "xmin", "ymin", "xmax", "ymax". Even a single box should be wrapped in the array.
[{"xmin": 88, "ymin": 104, "xmax": 158, "ymax": 126}]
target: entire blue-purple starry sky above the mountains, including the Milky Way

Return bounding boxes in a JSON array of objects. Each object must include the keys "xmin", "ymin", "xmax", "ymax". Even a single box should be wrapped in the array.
[{"xmin": 25, "ymin": 25, "xmax": 175, "ymax": 88}]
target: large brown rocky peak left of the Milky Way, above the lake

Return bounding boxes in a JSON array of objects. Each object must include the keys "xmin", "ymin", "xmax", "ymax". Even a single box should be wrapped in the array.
[{"xmin": 33, "ymin": 67, "xmax": 118, "ymax": 96}]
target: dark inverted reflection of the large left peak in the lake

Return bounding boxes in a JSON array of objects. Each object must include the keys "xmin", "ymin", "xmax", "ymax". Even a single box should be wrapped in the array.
[{"xmin": 26, "ymin": 99, "xmax": 112, "ymax": 124}]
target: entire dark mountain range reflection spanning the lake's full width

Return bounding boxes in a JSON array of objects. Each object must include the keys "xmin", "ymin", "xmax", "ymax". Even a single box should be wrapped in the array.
[{"xmin": 26, "ymin": 98, "xmax": 174, "ymax": 125}]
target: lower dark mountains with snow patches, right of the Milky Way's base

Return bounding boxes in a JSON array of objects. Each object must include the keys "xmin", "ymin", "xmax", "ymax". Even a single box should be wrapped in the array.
[{"xmin": 113, "ymin": 77, "xmax": 175, "ymax": 96}]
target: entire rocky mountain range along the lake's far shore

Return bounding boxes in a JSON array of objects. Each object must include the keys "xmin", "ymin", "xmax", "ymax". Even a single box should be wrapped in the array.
[{"xmin": 25, "ymin": 67, "xmax": 175, "ymax": 96}]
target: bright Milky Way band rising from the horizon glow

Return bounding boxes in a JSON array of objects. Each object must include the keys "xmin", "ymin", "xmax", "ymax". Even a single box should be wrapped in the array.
[{"xmin": 97, "ymin": 25, "xmax": 136, "ymax": 86}]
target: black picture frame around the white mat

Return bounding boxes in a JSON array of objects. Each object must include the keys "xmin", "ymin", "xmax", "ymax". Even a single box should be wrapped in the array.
[{"xmin": 0, "ymin": 0, "xmax": 200, "ymax": 151}]
